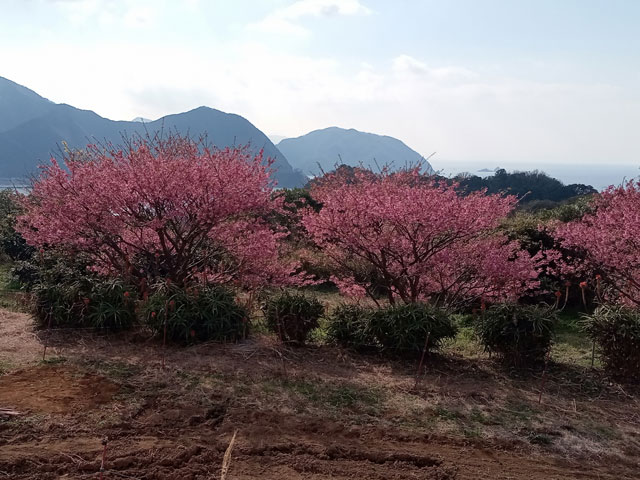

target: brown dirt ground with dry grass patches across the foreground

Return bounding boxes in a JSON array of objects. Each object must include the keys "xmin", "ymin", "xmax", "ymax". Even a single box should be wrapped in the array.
[{"xmin": 0, "ymin": 311, "xmax": 640, "ymax": 480}]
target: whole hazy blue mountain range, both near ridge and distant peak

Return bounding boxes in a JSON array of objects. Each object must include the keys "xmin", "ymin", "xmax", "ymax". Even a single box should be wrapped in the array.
[{"xmin": 0, "ymin": 77, "xmax": 432, "ymax": 187}]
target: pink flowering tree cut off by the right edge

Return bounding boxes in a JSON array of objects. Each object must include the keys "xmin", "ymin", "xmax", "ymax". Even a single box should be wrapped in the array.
[{"xmin": 555, "ymin": 181, "xmax": 640, "ymax": 305}]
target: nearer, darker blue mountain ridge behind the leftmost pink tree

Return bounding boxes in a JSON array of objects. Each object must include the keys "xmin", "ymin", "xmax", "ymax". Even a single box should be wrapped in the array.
[{"xmin": 0, "ymin": 77, "xmax": 306, "ymax": 187}]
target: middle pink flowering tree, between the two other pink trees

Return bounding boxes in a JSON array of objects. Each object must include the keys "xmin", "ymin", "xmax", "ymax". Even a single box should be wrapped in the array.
[{"xmin": 302, "ymin": 169, "xmax": 538, "ymax": 308}]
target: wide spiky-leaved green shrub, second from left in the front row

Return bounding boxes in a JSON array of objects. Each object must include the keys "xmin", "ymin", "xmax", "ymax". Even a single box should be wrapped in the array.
[{"xmin": 143, "ymin": 285, "xmax": 249, "ymax": 343}]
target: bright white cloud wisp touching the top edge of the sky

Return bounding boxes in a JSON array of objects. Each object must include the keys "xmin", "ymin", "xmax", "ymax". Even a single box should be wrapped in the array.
[{"xmin": 247, "ymin": 0, "xmax": 372, "ymax": 35}]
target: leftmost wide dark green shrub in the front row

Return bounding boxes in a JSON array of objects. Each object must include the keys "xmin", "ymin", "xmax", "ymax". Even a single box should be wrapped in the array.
[{"xmin": 32, "ymin": 276, "xmax": 136, "ymax": 330}]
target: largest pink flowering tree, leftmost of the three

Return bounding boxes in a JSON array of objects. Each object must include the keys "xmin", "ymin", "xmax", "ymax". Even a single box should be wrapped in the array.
[{"xmin": 18, "ymin": 136, "xmax": 299, "ymax": 287}]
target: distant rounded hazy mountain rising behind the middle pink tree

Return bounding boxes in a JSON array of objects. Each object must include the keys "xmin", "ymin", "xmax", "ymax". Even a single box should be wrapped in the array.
[{"xmin": 278, "ymin": 127, "xmax": 433, "ymax": 175}]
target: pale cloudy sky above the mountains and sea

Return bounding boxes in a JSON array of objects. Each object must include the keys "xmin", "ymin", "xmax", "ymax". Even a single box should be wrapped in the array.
[{"xmin": 0, "ymin": 0, "xmax": 640, "ymax": 172}]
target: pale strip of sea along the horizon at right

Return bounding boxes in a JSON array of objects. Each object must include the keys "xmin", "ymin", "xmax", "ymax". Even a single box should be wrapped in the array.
[{"xmin": 430, "ymin": 159, "xmax": 640, "ymax": 190}]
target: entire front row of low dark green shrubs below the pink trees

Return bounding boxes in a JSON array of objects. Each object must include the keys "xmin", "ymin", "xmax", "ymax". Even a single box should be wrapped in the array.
[{"xmin": 14, "ymin": 254, "xmax": 640, "ymax": 378}]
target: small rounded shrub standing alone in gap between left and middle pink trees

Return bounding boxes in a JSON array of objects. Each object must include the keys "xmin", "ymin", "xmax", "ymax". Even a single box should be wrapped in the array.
[{"xmin": 264, "ymin": 292, "xmax": 324, "ymax": 345}]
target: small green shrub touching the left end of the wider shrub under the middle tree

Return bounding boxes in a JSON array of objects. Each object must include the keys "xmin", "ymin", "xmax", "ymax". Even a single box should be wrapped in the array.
[{"xmin": 327, "ymin": 303, "xmax": 379, "ymax": 351}]
